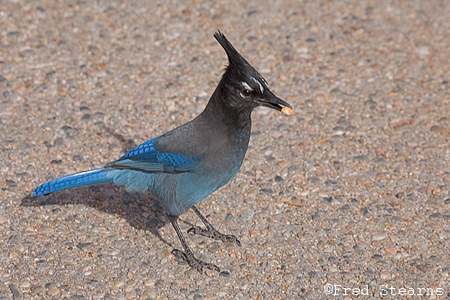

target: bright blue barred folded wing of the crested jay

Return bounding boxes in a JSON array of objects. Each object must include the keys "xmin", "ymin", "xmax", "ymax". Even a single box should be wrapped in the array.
[{"xmin": 105, "ymin": 138, "xmax": 199, "ymax": 173}]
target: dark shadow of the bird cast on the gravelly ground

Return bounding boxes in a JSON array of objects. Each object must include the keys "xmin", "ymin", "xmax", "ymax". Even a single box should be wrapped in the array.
[{"xmin": 21, "ymin": 129, "xmax": 181, "ymax": 247}]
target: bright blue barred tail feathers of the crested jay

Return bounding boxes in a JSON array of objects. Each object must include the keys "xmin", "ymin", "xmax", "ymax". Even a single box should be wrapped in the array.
[{"xmin": 31, "ymin": 168, "xmax": 112, "ymax": 196}]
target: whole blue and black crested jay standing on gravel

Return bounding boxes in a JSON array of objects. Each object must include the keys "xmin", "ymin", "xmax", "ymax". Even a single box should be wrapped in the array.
[{"xmin": 32, "ymin": 31, "xmax": 293, "ymax": 273}]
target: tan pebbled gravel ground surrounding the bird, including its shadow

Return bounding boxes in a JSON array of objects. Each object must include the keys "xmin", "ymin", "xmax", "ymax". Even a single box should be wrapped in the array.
[{"xmin": 0, "ymin": 0, "xmax": 450, "ymax": 300}]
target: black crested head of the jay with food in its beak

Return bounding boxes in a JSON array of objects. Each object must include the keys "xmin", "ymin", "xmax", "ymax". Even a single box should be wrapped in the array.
[{"xmin": 214, "ymin": 31, "xmax": 293, "ymax": 115}]
